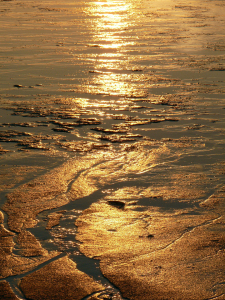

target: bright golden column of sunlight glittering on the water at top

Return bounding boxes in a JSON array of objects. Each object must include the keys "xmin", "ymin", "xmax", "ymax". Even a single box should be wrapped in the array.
[{"xmin": 85, "ymin": 0, "xmax": 142, "ymax": 97}]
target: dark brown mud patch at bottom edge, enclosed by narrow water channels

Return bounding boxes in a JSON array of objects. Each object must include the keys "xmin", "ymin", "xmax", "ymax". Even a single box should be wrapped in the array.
[{"xmin": 20, "ymin": 257, "xmax": 104, "ymax": 300}]
